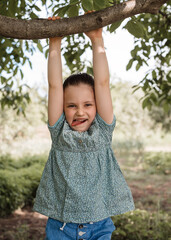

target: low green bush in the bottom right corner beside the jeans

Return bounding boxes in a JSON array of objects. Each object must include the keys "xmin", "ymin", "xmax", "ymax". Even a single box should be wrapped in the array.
[{"xmin": 111, "ymin": 209, "xmax": 171, "ymax": 240}]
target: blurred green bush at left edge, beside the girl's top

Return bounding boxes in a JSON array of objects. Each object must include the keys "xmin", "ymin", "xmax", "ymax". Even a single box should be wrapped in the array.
[{"xmin": 0, "ymin": 156, "xmax": 47, "ymax": 217}]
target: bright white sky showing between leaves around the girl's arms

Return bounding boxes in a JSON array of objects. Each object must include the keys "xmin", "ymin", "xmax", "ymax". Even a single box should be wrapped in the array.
[{"xmin": 23, "ymin": 28, "xmax": 151, "ymax": 89}]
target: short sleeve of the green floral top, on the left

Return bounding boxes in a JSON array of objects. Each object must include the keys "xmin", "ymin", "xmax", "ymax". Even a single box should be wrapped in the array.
[{"xmin": 48, "ymin": 113, "xmax": 65, "ymax": 141}]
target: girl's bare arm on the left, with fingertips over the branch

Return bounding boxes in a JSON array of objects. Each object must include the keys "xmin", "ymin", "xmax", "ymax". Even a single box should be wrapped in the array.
[{"xmin": 48, "ymin": 17, "xmax": 63, "ymax": 126}]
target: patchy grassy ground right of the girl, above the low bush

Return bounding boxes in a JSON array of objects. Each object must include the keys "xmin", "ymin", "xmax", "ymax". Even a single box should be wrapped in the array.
[{"xmin": 116, "ymin": 151, "xmax": 171, "ymax": 212}]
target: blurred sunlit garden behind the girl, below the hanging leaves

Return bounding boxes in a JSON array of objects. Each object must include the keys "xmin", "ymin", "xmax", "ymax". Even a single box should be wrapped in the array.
[{"xmin": 0, "ymin": 78, "xmax": 171, "ymax": 240}]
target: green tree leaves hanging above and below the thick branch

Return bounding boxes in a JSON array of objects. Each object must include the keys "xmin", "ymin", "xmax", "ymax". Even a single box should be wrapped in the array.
[{"xmin": 0, "ymin": 0, "xmax": 171, "ymax": 118}]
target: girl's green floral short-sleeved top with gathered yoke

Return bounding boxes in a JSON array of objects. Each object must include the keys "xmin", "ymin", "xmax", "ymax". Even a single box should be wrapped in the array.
[{"xmin": 34, "ymin": 113, "xmax": 134, "ymax": 223}]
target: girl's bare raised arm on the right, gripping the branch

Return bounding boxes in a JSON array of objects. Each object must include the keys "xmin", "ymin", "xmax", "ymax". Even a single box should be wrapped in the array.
[{"xmin": 86, "ymin": 28, "xmax": 113, "ymax": 124}]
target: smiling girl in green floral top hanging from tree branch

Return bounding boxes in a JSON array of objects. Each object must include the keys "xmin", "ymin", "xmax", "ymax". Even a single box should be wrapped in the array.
[{"xmin": 34, "ymin": 17, "xmax": 134, "ymax": 240}]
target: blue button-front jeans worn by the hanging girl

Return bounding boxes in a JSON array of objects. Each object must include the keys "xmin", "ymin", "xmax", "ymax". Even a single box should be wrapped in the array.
[{"xmin": 45, "ymin": 217, "xmax": 115, "ymax": 240}]
